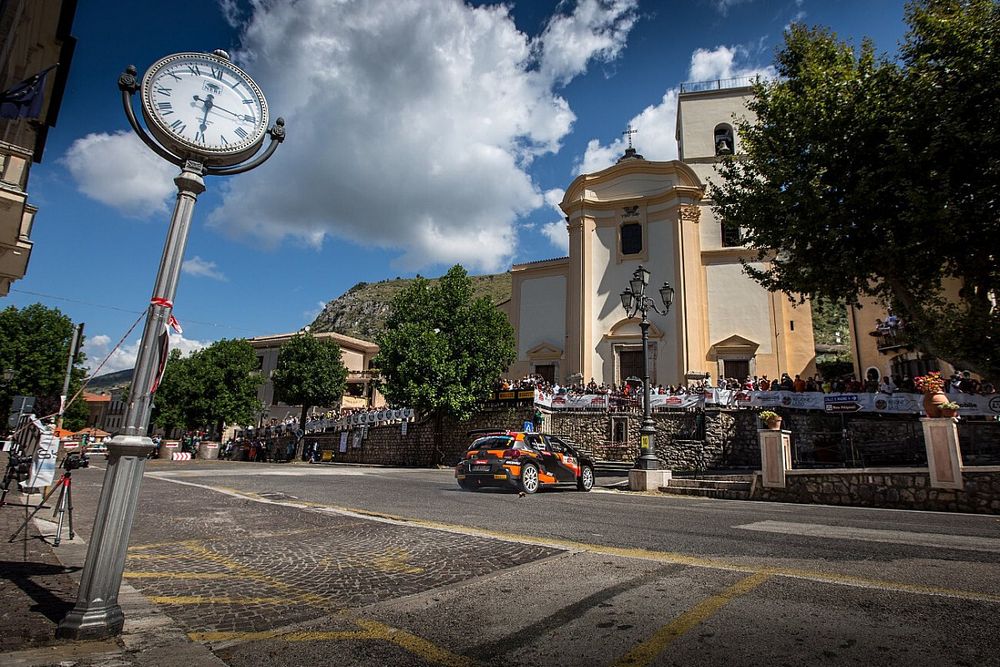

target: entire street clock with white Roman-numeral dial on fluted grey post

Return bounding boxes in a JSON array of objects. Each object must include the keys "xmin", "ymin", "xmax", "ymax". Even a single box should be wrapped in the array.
[{"xmin": 56, "ymin": 51, "xmax": 285, "ymax": 639}]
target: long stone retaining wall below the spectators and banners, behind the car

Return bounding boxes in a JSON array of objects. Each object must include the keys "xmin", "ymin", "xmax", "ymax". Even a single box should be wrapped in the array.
[{"xmin": 294, "ymin": 405, "xmax": 1000, "ymax": 471}]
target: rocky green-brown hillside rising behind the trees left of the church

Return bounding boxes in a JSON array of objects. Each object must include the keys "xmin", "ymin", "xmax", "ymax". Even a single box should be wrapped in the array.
[{"xmin": 310, "ymin": 272, "xmax": 510, "ymax": 341}]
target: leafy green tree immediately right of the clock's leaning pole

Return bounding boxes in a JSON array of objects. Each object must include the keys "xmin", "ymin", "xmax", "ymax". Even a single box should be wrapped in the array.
[{"xmin": 153, "ymin": 339, "xmax": 261, "ymax": 435}]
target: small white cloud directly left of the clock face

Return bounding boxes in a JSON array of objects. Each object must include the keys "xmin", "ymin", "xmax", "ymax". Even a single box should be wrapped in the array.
[{"xmin": 59, "ymin": 130, "xmax": 179, "ymax": 218}]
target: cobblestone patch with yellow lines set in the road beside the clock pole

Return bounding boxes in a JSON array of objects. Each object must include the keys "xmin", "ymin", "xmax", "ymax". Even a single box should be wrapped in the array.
[{"xmin": 120, "ymin": 482, "xmax": 558, "ymax": 636}]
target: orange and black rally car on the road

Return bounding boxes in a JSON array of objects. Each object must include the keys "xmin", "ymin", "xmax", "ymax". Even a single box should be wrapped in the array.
[{"xmin": 455, "ymin": 431, "xmax": 594, "ymax": 493}]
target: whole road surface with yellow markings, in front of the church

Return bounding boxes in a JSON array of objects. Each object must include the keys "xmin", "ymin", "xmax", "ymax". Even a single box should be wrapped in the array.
[{"xmin": 58, "ymin": 460, "xmax": 1000, "ymax": 666}]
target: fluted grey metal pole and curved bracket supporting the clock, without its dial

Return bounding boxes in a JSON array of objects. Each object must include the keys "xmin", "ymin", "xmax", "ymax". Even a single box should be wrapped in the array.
[{"xmin": 56, "ymin": 54, "xmax": 285, "ymax": 639}]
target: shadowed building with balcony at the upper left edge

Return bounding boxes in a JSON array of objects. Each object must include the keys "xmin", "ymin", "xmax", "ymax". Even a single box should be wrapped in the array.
[{"xmin": 0, "ymin": 0, "xmax": 76, "ymax": 296}]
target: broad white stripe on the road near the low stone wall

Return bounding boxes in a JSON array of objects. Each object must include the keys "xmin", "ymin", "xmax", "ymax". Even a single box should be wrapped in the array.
[{"xmin": 734, "ymin": 521, "xmax": 1000, "ymax": 553}]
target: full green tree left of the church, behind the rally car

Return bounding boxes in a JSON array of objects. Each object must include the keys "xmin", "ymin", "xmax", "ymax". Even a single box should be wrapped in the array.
[{"xmin": 375, "ymin": 265, "xmax": 516, "ymax": 464}]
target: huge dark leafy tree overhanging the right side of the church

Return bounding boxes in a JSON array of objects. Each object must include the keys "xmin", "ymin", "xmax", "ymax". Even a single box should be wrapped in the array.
[{"xmin": 711, "ymin": 0, "xmax": 1000, "ymax": 378}]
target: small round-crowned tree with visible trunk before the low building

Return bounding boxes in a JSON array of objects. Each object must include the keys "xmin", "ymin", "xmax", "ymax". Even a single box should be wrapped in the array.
[{"xmin": 271, "ymin": 332, "xmax": 347, "ymax": 457}]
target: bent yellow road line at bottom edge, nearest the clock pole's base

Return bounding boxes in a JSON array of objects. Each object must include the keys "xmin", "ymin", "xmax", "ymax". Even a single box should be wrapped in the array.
[{"xmin": 188, "ymin": 618, "xmax": 475, "ymax": 667}]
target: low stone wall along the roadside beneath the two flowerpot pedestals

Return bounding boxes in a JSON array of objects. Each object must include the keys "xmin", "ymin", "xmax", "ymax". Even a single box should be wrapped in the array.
[{"xmin": 750, "ymin": 466, "xmax": 1000, "ymax": 514}]
